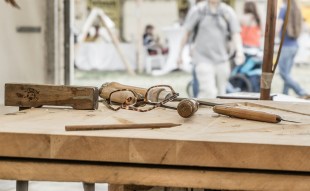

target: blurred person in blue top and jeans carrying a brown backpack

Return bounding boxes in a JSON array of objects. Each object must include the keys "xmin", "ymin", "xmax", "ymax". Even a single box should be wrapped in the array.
[{"xmin": 277, "ymin": 0, "xmax": 309, "ymax": 98}]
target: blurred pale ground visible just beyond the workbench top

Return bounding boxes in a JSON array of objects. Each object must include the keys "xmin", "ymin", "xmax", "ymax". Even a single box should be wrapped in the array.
[{"xmin": 74, "ymin": 65, "xmax": 310, "ymax": 97}]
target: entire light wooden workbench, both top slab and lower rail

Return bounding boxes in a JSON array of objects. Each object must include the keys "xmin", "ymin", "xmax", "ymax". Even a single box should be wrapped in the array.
[{"xmin": 0, "ymin": 101, "xmax": 310, "ymax": 190}]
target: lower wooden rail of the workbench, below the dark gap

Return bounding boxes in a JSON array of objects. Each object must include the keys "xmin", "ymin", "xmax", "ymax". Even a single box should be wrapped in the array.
[{"xmin": 0, "ymin": 160, "xmax": 310, "ymax": 190}]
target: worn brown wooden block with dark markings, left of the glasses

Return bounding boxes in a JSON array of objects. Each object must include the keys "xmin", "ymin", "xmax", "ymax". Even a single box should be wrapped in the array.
[{"xmin": 5, "ymin": 84, "xmax": 98, "ymax": 110}]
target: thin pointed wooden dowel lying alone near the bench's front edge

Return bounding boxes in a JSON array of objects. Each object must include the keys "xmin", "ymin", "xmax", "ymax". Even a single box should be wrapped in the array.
[{"xmin": 65, "ymin": 123, "xmax": 181, "ymax": 131}]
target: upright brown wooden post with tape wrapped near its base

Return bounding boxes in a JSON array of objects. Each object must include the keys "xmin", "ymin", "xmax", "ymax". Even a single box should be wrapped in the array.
[{"xmin": 260, "ymin": 0, "xmax": 277, "ymax": 100}]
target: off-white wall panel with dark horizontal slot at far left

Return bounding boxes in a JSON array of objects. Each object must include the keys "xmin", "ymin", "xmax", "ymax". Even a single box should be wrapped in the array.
[{"xmin": 0, "ymin": 0, "xmax": 46, "ymax": 104}]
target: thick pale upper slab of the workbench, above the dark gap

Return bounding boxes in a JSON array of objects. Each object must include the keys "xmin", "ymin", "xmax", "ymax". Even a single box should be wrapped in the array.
[{"xmin": 0, "ymin": 102, "xmax": 310, "ymax": 171}]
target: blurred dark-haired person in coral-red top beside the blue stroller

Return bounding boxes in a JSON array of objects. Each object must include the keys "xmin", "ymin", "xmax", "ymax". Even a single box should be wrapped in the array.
[{"xmin": 241, "ymin": 1, "xmax": 261, "ymax": 48}]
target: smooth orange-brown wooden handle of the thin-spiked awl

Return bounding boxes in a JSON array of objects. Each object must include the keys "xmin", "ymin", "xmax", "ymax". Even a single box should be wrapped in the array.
[{"xmin": 213, "ymin": 105, "xmax": 282, "ymax": 123}]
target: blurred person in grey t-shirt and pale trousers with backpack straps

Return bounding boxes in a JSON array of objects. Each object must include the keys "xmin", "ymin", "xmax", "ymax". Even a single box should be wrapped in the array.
[{"xmin": 178, "ymin": 0, "xmax": 244, "ymax": 98}]
